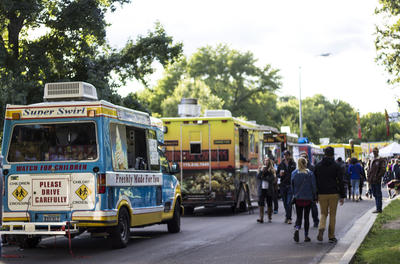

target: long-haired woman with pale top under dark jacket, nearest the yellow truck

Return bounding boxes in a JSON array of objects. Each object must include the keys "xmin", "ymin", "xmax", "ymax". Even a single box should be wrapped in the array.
[{"xmin": 257, "ymin": 158, "xmax": 276, "ymax": 223}]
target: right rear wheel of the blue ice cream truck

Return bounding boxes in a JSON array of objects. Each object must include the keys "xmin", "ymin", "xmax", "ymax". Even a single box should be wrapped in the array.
[{"xmin": 110, "ymin": 207, "xmax": 130, "ymax": 248}]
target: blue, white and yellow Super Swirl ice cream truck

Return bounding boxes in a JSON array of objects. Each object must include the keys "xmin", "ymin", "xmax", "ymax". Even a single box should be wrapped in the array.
[{"xmin": 0, "ymin": 82, "xmax": 183, "ymax": 248}]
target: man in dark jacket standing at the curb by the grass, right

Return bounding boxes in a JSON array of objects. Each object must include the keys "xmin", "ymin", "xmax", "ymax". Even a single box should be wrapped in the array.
[{"xmin": 367, "ymin": 147, "xmax": 386, "ymax": 213}]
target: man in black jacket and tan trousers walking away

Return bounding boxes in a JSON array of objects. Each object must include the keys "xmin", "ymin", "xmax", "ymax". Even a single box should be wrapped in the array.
[{"xmin": 314, "ymin": 147, "xmax": 346, "ymax": 243}]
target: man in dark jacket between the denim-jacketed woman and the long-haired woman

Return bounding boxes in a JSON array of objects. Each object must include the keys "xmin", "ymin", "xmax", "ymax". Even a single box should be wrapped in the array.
[{"xmin": 277, "ymin": 150, "xmax": 296, "ymax": 225}]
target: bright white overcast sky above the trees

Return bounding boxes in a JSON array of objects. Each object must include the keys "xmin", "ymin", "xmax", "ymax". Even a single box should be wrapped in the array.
[{"xmin": 107, "ymin": 0, "xmax": 398, "ymax": 115}]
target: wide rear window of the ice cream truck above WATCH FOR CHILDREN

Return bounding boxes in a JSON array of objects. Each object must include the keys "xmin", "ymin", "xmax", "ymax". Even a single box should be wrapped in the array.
[{"xmin": 7, "ymin": 122, "xmax": 97, "ymax": 162}]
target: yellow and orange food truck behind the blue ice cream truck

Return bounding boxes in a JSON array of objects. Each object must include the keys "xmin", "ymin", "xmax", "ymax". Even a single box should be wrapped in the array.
[{"xmin": 162, "ymin": 99, "xmax": 277, "ymax": 214}]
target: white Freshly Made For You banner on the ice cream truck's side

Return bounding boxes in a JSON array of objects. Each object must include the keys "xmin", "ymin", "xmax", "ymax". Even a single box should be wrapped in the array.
[{"xmin": 106, "ymin": 172, "xmax": 162, "ymax": 186}]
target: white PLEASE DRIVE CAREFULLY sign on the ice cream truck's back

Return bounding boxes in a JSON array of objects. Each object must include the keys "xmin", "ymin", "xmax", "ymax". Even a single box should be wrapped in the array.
[{"xmin": 32, "ymin": 178, "xmax": 69, "ymax": 206}]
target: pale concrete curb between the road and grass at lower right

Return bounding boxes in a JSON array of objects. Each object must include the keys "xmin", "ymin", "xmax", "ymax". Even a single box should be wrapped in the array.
[{"xmin": 319, "ymin": 199, "xmax": 395, "ymax": 264}]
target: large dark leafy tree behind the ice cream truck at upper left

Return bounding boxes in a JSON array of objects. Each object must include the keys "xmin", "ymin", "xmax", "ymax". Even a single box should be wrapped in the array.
[{"xmin": 0, "ymin": 0, "xmax": 182, "ymax": 126}]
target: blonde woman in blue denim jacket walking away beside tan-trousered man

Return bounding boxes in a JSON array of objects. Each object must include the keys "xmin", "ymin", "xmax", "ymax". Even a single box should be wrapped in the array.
[{"xmin": 291, "ymin": 157, "xmax": 317, "ymax": 242}]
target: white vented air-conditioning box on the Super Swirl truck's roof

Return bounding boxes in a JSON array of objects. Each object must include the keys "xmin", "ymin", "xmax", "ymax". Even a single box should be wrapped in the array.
[{"xmin": 43, "ymin": 82, "xmax": 98, "ymax": 101}]
